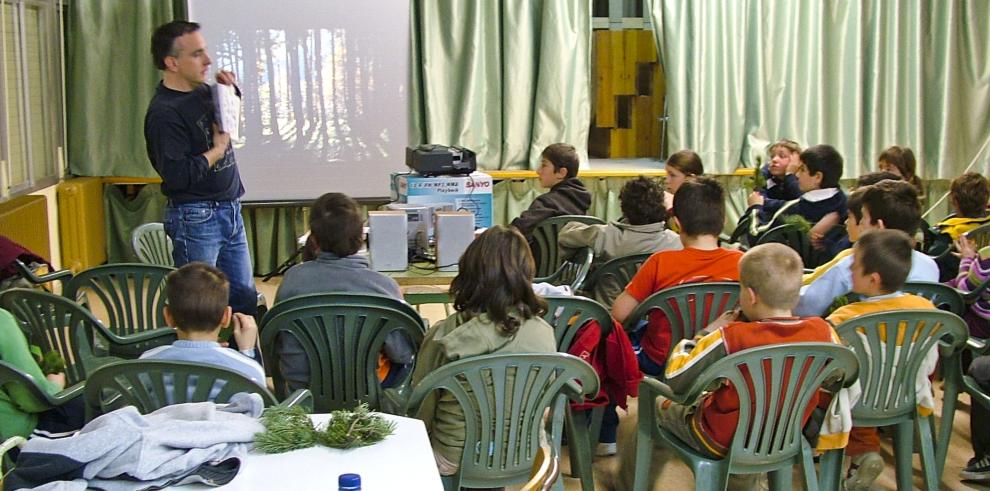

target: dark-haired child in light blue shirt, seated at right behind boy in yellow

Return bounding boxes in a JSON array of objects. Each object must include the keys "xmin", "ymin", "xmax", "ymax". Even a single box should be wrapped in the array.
[{"xmin": 794, "ymin": 180, "xmax": 938, "ymax": 316}]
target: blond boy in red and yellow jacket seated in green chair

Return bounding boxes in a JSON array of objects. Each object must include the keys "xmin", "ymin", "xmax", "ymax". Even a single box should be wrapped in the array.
[{"xmin": 622, "ymin": 244, "xmax": 838, "ymax": 487}]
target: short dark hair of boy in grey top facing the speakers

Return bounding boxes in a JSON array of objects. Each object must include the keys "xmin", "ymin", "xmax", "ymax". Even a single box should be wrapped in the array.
[{"xmin": 309, "ymin": 193, "xmax": 364, "ymax": 257}]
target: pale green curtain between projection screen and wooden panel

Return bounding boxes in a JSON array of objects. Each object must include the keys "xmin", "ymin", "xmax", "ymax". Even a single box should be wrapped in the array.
[{"xmin": 409, "ymin": 0, "xmax": 591, "ymax": 169}]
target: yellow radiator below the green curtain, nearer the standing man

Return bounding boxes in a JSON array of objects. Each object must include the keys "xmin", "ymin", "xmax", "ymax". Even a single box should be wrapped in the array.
[{"xmin": 56, "ymin": 177, "xmax": 107, "ymax": 273}]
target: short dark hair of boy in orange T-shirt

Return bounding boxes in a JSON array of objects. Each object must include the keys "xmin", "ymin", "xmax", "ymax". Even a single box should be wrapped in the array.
[{"xmin": 674, "ymin": 176, "xmax": 725, "ymax": 237}]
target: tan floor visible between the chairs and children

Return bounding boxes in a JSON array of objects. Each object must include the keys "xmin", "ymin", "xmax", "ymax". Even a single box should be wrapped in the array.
[{"xmin": 258, "ymin": 278, "xmax": 990, "ymax": 491}]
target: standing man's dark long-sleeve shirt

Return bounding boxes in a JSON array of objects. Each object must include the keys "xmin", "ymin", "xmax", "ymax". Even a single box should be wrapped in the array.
[{"xmin": 144, "ymin": 83, "xmax": 244, "ymax": 203}]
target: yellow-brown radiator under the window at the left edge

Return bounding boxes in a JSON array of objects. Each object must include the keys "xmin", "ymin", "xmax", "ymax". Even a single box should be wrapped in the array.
[{"xmin": 0, "ymin": 195, "xmax": 52, "ymax": 261}]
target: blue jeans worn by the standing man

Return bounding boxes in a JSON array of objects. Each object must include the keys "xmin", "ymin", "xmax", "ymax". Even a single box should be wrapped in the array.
[{"xmin": 165, "ymin": 200, "xmax": 258, "ymax": 315}]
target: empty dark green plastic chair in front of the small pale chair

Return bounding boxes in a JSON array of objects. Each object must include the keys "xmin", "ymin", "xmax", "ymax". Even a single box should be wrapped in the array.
[{"xmin": 63, "ymin": 264, "xmax": 175, "ymax": 358}]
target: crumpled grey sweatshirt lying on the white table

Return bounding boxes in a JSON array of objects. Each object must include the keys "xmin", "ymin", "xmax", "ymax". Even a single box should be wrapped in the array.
[{"xmin": 4, "ymin": 393, "xmax": 265, "ymax": 491}]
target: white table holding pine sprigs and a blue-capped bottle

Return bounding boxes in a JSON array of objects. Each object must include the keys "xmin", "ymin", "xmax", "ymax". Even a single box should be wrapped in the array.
[{"xmin": 204, "ymin": 414, "xmax": 443, "ymax": 491}]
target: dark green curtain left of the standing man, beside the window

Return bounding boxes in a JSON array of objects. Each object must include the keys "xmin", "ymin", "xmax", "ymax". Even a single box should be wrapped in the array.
[{"xmin": 65, "ymin": 0, "xmax": 186, "ymax": 177}]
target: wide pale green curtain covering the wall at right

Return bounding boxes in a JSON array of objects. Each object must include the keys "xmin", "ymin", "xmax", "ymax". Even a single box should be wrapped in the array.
[{"xmin": 649, "ymin": 0, "xmax": 990, "ymax": 179}]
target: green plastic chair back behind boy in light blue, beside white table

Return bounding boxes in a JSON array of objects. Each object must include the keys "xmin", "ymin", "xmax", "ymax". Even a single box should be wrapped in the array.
[{"xmin": 83, "ymin": 360, "xmax": 313, "ymax": 421}]
